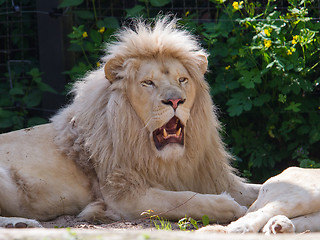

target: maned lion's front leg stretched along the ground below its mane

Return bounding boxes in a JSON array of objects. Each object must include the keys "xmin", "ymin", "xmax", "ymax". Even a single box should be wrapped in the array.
[{"xmin": 107, "ymin": 188, "xmax": 246, "ymax": 223}]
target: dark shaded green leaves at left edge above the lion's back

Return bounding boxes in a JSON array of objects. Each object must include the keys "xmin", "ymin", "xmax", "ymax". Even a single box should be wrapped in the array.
[{"xmin": 0, "ymin": 64, "xmax": 56, "ymax": 132}]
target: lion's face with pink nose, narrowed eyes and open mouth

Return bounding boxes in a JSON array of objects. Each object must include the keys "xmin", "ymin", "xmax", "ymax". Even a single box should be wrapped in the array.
[{"xmin": 127, "ymin": 58, "xmax": 196, "ymax": 158}]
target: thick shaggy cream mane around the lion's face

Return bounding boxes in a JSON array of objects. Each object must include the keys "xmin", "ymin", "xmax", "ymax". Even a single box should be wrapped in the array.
[{"xmin": 52, "ymin": 17, "xmax": 241, "ymax": 202}]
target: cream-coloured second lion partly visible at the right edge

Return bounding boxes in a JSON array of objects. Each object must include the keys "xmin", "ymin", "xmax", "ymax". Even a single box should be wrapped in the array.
[{"xmin": 201, "ymin": 167, "xmax": 320, "ymax": 234}]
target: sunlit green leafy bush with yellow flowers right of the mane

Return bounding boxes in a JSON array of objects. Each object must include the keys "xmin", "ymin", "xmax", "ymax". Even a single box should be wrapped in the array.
[{"xmin": 200, "ymin": 0, "xmax": 320, "ymax": 181}]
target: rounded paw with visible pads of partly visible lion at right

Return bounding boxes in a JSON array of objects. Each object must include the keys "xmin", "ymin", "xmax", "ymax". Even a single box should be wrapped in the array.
[{"xmin": 262, "ymin": 215, "xmax": 295, "ymax": 235}]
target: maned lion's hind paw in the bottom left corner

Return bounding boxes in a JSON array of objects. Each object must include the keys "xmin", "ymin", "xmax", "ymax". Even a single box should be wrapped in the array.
[{"xmin": 0, "ymin": 217, "xmax": 42, "ymax": 228}]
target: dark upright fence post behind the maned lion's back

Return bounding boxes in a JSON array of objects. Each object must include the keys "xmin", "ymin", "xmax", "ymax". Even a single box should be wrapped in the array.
[{"xmin": 36, "ymin": 0, "xmax": 70, "ymax": 117}]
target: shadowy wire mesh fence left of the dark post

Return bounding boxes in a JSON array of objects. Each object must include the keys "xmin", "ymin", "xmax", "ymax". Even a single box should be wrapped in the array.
[{"xmin": 0, "ymin": 1, "xmax": 38, "ymax": 82}]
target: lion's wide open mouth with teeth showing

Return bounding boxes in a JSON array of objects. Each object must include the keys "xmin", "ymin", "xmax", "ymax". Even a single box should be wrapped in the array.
[{"xmin": 153, "ymin": 117, "xmax": 184, "ymax": 150}]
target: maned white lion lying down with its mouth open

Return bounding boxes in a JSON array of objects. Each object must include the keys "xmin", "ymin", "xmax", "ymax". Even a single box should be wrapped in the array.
[{"xmin": 0, "ymin": 17, "xmax": 260, "ymax": 227}]
